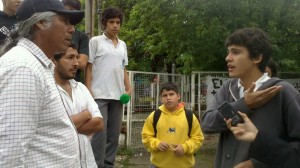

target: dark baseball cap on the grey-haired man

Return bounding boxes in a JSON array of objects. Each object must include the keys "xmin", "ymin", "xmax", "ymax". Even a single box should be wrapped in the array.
[{"xmin": 16, "ymin": 0, "xmax": 84, "ymax": 25}]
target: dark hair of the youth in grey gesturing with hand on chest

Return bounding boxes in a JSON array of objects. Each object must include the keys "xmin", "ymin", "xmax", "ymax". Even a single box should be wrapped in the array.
[{"xmin": 225, "ymin": 28, "xmax": 272, "ymax": 72}]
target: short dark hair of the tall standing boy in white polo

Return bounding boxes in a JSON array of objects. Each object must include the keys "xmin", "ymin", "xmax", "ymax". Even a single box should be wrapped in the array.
[{"xmin": 101, "ymin": 7, "xmax": 124, "ymax": 29}]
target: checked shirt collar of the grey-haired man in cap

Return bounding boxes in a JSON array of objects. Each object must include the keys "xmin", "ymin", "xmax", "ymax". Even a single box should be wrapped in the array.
[{"xmin": 17, "ymin": 38, "xmax": 54, "ymax": 69}]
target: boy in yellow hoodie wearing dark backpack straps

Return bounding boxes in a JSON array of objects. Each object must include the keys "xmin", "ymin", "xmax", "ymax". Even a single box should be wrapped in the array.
[{"xmin": 142, "ymin": 83, "xmax": 204, "ymax": 168}]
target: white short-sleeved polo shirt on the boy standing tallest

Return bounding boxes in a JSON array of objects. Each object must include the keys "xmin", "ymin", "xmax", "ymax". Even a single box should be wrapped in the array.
[{"xmin": 88, "ymin": 34, "xmax": 128, "ymax": 100}]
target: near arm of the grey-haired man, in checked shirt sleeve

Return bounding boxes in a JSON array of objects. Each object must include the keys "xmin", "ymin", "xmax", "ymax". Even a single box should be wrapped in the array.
[{"xmin": 0, "ymin": 67, "xmax": 40, "ymax": 167}]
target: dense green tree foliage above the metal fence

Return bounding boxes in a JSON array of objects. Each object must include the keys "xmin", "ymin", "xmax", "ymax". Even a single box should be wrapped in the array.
[{"xmin": 94, "ymin": 0, "xmax": 300, "ymax": 74}]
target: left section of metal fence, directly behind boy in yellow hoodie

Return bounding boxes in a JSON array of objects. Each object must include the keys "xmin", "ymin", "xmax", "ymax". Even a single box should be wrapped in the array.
[{"xmin": 123, "ymin": 71, "xmax": 190, "ymax": 148}]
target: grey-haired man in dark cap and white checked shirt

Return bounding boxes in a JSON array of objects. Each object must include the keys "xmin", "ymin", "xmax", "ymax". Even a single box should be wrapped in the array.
[{"xmin": 0, "ymin": 0, "xmax": 83, "ymax": 168}]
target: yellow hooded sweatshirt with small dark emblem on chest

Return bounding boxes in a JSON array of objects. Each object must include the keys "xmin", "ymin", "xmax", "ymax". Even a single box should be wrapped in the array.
[{"xmin": 142, "ymin": 103, "xmax": 204, "ymax": 168}]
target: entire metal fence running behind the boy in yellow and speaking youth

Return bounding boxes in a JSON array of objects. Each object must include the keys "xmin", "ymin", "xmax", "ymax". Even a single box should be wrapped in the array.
[{"xmin": 123, "ymin": 71, "xmax": 300, "ymax": 148}]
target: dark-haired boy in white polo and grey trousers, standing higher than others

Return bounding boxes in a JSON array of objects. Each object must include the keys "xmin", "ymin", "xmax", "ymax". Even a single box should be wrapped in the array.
[{"xmin": 85, "ymin": 7, "xmax": 131, "ymax": 168}]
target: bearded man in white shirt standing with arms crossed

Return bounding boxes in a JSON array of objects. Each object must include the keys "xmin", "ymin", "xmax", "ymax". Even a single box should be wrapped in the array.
[{"xmin": 52, "ymin": 43, "xmax": 103, "ymax": 168}]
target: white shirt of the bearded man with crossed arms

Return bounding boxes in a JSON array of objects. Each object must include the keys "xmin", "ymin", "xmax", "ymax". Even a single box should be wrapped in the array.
[{"xmin": 57, "ymin": 79, "xmax": 102, "ymax": 168}]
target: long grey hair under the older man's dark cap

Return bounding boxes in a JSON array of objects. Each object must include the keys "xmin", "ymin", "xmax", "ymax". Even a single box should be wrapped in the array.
[{"xmin": 0, "ymin": 12, "xmax": 57, "ymax": 57}]
